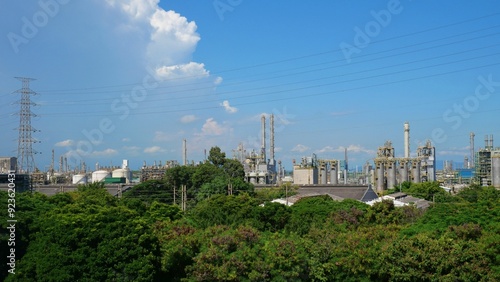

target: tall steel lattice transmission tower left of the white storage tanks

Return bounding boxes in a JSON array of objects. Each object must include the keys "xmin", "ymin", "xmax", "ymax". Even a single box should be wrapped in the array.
[{"xmin": 14, "ymin": 77, "xmax": 39, "ymax": 174}]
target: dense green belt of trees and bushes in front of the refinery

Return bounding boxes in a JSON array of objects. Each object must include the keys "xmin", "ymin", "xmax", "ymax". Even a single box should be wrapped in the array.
[{"xmin": 0, "ymin": 148, "xmax": 500, "ymax": 281}]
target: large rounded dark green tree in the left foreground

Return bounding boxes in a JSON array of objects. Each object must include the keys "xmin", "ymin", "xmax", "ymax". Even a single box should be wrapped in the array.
[{"xmin": 15, "ymin": 185, "xmax": 161, "ymax": 281}]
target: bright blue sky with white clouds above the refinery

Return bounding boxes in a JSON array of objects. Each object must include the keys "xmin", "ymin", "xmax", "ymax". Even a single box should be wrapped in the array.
[{"xmin": 0, "ymin": 0, "xmax": 500, "ymax": 170}]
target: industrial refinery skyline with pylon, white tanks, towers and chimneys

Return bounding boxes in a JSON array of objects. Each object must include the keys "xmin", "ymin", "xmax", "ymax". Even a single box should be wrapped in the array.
[{"xmin": 0, "ymin": 78, "xmax": 500, "ymax": 193}]
